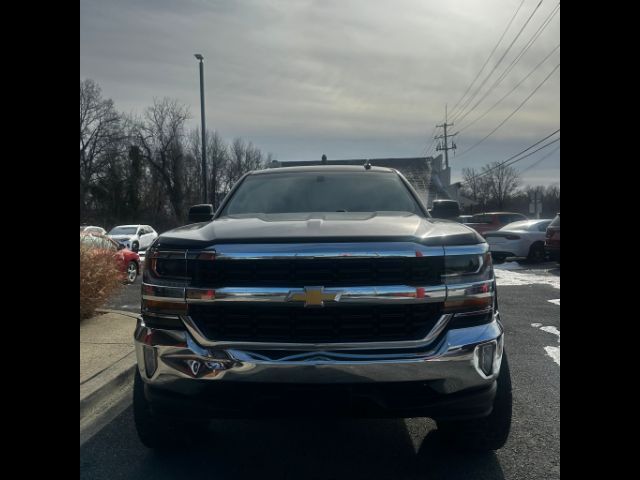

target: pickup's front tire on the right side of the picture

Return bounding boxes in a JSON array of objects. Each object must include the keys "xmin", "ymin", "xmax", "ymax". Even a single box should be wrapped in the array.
[{"xmin": 438, "ymin": 352, "xmax": 512, "ymax": 452}]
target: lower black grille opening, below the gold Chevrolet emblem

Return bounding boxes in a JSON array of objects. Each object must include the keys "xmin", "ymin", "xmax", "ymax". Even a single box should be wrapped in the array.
[{"xmin": 189, "ymin": 303, "xmax": 442, "ymax": 343}]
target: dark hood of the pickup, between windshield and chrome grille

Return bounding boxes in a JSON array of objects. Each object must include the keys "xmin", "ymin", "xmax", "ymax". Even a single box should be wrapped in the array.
[{"xmin": 156, "ymin": 212, "xmax": 484, "ymax": 248}]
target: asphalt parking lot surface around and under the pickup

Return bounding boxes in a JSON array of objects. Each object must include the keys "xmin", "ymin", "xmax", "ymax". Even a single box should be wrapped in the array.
[{"xmin": 87, "ymin": 262, "xmax": 560, "ymax": 480}]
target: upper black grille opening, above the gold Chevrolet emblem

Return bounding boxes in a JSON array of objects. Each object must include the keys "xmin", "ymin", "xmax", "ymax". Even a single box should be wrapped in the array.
[{"xmin": 188, "ymin": 257, "xmax": 444, "ymax": 288}]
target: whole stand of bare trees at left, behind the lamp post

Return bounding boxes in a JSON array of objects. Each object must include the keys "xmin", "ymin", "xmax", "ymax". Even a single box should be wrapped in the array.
[{"xmin": 80, "ymin": 80, "xmax": 273, "ymax": 231}]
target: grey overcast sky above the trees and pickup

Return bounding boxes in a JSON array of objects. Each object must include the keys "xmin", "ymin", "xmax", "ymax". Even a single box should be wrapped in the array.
[{"xmin": 80, "ymin": 0, "xmax": 560, "ymax": 184}]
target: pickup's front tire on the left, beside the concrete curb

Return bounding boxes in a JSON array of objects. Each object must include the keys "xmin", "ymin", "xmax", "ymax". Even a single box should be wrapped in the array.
[{"xmin": 133, "ymin": 370, "xmax": 207, "ymax": 450}]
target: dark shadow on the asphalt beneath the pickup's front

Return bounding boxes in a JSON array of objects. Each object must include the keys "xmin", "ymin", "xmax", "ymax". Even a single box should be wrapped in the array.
[{"xmin": 81, "ymin": 409, "xmax": 504, "ymax": 480}]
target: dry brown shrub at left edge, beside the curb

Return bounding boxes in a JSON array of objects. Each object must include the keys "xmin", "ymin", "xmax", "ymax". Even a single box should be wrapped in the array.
[{"xmin": 80, "ymin": 243, "xmax": 122, "ymax": 320}]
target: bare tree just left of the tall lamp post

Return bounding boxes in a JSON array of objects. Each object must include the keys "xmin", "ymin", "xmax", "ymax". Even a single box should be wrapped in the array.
[{"xmin": 135, "ymin": 98, "xmax": 190, "ymax": 222}]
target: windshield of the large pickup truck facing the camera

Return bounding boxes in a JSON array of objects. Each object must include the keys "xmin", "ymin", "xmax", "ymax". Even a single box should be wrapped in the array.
[{"xmin": 222, "ymin": 171, "xmax": 421, "ymax": 216}]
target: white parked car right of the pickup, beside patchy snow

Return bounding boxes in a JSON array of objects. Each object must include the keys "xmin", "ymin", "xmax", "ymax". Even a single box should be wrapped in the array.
[{"xmin": 484, "ymin": 219, "xmax": 551, "ymax": 262}]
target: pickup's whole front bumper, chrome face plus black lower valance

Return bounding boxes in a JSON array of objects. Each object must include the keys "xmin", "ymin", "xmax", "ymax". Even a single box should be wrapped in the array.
[{"xmin": 135, "ymin": 314, "xmax": 503, "ymax": 418}]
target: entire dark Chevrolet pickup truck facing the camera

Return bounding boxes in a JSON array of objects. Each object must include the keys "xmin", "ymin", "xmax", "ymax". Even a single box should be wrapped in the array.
[{"xmin": 134, "ymin": 165, "xmax": 511, "ymax": 450}]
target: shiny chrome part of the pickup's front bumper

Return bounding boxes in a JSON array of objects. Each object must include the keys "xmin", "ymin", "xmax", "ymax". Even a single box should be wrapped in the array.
[{"xmin": 134, "ymin": 313, "xmax": 503, "ymax": 394}]
